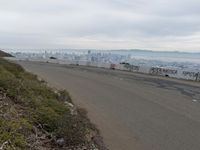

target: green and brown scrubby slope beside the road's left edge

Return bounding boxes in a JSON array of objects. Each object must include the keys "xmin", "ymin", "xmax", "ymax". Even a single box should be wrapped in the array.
[{"xmin": 0, "ymin": 53, "xmax": 106, "ymax": 150}]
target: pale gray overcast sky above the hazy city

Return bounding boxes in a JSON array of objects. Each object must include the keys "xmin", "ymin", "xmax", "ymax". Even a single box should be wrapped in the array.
[{"xmin": 0, "ymin": 0, "xmax": 200, "ymax": 52}]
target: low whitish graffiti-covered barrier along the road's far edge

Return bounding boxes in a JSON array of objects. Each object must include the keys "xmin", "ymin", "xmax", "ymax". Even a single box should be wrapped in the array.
[{"xmin": 6, "ymin": 58, "xmax": 200, "ymax": 81}]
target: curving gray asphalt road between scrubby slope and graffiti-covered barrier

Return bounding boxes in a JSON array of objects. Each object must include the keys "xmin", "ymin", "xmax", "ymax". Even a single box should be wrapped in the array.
[{"xmin": 16, "ymin": 62, "xmax": 200, "ymax": 150}]
